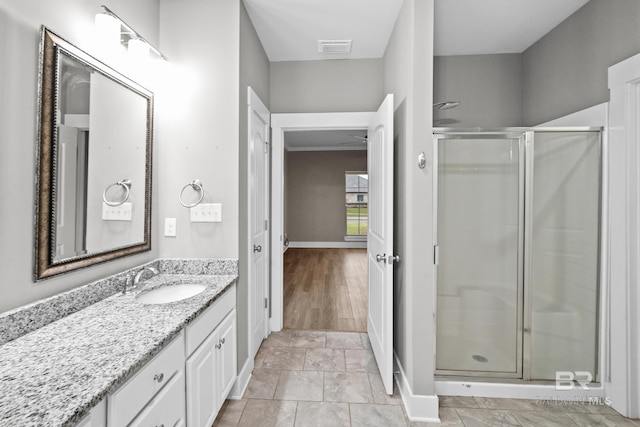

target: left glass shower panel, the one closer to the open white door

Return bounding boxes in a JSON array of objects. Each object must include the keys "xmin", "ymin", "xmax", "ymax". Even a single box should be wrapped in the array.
[{"xmin": 434, "ymin": 132, "xmax": 524, "ymax": 378}]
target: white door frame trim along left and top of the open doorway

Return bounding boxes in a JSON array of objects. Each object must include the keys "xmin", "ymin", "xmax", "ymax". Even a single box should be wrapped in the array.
[{"xmin": 270, "ymin": 112, "xmax": 374, "ymax": 331}]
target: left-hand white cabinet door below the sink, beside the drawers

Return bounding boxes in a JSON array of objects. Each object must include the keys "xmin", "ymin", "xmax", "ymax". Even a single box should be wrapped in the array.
[{"xmin": 186, "ymin": 332, "xmax": 219, "ymax": 427}]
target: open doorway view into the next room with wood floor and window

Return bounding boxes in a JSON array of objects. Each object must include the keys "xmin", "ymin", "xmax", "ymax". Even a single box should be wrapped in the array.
[{"xmin": 283, "ymin": 135, "xmax": 368, "ymax": 332}]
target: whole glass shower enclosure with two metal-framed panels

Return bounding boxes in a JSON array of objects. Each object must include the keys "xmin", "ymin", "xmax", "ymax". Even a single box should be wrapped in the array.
[{"xmin": 434, "ymin": 128, "xmax": 602, "ymax": 381}]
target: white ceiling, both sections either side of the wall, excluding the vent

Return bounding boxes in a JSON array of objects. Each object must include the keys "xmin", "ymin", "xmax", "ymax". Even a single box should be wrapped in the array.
[{"xmin": 244, "ymin": 0, "xmax": 588, "ymax": 62}]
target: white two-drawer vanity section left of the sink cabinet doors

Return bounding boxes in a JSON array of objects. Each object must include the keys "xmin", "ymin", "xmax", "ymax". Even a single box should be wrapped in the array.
[{"xmin": 107, "ymin": 332, "xmax": 186, "ymax": 427}]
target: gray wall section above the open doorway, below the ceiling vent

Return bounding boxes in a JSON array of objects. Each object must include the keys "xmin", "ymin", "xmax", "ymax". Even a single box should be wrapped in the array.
[{"xmin": 270, "ymin": 59, "xmax": 384, "ymax": 113}]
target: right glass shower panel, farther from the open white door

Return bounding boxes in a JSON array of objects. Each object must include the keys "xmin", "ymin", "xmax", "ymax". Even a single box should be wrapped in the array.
[{"xmin": 525, "ymin": 131, "xmax": 601, "ymax": 381}]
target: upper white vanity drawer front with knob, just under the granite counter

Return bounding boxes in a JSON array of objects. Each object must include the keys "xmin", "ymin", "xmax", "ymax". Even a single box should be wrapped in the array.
[{"xmin": 107, "ymin": 332, "xmax": 184, "ymax": 427}]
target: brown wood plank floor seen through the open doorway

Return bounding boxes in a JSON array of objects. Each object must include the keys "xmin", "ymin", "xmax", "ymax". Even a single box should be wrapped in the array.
[{"xmin": 284, "ymin": 248, "xmax": 367, "ymax": 332}]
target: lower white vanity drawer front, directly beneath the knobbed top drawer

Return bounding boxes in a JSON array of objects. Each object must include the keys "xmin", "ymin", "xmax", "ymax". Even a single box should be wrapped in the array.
[{"xmin": 129, "ymin": 370, "xmax": 185, "ymax": 427}]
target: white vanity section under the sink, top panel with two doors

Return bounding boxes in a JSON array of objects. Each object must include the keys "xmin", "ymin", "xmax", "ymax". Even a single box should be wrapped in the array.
[{"xmin": 186, "ymin": 286, "xmax": 237, "ymax": 427}]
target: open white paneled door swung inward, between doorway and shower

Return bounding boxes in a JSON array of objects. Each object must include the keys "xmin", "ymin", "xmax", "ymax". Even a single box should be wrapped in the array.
[{"xmin": 367, "ymin": 95, "xmax": 396, "ymax": 394}]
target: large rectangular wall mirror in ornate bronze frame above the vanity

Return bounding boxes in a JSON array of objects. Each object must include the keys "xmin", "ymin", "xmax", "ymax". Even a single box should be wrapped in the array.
[{"xmin": 34, "ymin": 27, "xmax": 153, "ymax": 280}]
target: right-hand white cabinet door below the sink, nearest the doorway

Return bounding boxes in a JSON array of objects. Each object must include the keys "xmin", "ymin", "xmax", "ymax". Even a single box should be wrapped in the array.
[{"xmin": 215, "ymin": 310, "xmax": 238, "ymax": 412}]
